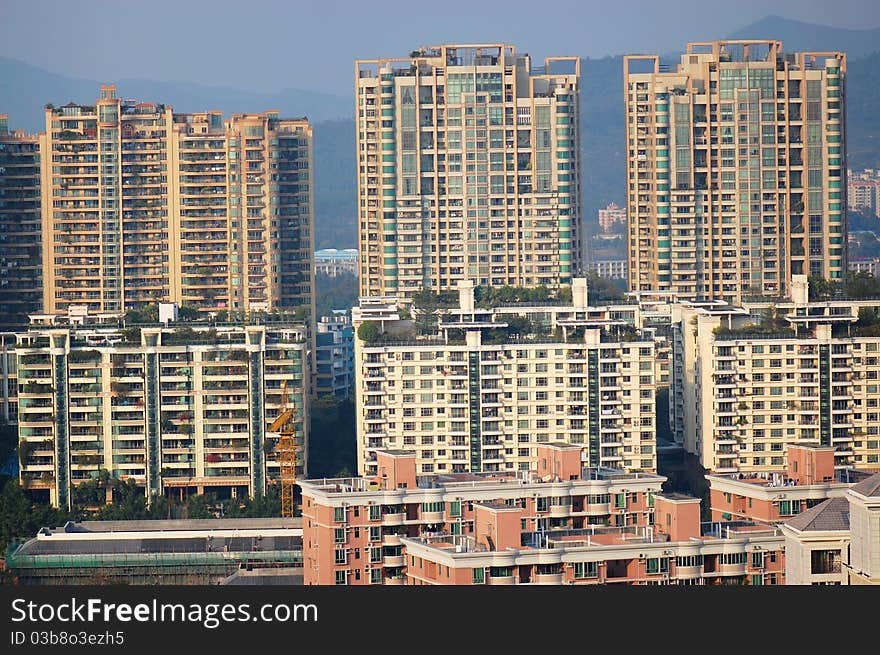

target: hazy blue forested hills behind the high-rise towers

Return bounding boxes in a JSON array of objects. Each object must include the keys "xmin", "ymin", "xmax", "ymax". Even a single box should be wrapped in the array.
[{"xmin": 0, "ymin": 16, "xmax": 880, "ymax": 248}]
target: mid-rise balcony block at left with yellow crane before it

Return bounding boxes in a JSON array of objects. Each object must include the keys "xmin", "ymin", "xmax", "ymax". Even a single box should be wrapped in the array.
[{"xmin": 15, "ymin": 323, "xmax": 309, "ymax": 507}]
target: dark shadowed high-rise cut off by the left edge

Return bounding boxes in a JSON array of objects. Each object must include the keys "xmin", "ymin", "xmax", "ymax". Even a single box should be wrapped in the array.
[{"xmin": 0, "ymin": 114, "xmax": 43, "ymax": 326}]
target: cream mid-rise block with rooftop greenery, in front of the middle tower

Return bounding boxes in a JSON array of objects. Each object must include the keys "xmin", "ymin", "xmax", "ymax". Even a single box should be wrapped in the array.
[{"xmin": 353, "ymin": 279, "xmax": 657, "ymax": 475}]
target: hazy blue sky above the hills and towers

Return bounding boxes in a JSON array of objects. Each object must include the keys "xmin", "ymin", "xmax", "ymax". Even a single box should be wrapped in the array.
[{"xmin": 0, "ymin": 0, "xmax": 880, "ymax": 95}]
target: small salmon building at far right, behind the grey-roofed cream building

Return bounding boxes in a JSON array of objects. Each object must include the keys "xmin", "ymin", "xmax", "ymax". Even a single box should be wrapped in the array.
[{"xmin": 706, "ymin": 445, "xmax": 870, "ymax": 523}]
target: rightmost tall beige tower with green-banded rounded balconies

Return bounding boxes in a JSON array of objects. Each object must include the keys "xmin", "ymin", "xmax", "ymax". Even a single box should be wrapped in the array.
[{"xmin": 624, "ymin": 41, "xmax": 847, "ymax": 302}]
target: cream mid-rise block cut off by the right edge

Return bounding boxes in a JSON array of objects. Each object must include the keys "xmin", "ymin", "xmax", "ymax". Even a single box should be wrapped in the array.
[{"xmin": 671, "ymin": 291, "xmax": 880, "ymax": 475}]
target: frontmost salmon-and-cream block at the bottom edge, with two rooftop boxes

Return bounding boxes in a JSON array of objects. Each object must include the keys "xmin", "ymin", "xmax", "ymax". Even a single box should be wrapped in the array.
[{"xmin": 402, "ymin": 494, "xmax": 785, "ymax": 585}]
